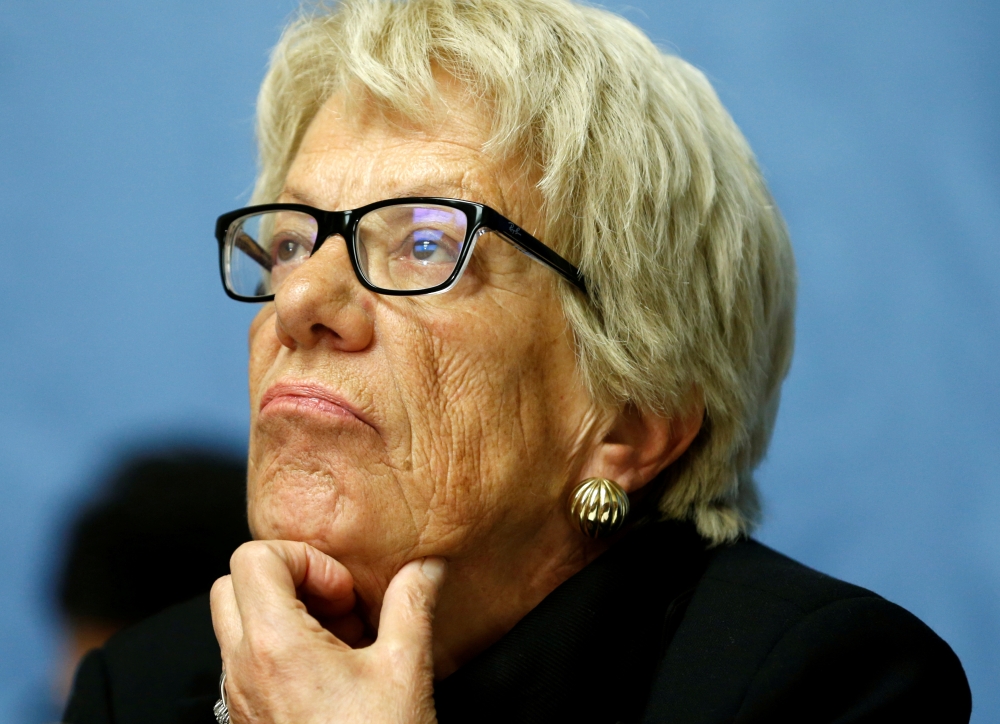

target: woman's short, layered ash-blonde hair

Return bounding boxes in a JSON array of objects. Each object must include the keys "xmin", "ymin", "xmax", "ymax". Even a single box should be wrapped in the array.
[{"xmin": 254, "ymin": 0, "xmax": 795, "ymax": 543}]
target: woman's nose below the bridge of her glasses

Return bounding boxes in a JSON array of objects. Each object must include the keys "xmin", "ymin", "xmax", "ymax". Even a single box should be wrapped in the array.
[{"xmin": 274, "ymin": 236, "xmax": 375, "ymax": 352}]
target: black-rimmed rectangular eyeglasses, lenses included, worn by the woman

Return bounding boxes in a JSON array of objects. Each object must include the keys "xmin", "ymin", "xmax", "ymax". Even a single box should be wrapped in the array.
[{"xmin": 215, "ymin": 197, "xmax": 587, "ymax": 302}]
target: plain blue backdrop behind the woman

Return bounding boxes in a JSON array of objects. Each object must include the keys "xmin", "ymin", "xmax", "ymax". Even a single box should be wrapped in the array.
[{"xmin": 0, "ymin": 0, "xmax": 1000, "ymax": 722}]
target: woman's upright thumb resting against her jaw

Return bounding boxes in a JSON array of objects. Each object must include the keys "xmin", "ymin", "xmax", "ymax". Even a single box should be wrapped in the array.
[{"xmin": 375, "ymin": 558, "xmax": 447, "ymax": 656}]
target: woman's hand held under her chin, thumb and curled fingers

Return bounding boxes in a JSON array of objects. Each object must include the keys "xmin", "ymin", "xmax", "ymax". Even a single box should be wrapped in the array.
[{"xmin": 212, "ymin": 541, "xmax": 445, "ymax": 724}]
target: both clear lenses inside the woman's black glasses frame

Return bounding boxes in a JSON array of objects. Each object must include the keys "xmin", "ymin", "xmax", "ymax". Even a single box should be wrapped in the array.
[{"xmin": 224, "ymin": 204, "xmax": 468, "ymax": 297}]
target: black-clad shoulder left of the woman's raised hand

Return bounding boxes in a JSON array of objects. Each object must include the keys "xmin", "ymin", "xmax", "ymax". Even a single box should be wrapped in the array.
[{"xmin": 64, "ymin": 595, "xmax": 222, "ymax": 724}]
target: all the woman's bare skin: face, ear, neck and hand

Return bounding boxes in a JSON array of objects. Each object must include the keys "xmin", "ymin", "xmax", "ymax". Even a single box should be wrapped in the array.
[{"xmin": 213, "ymin": 83, "xmax": 700, "ymax": 722}]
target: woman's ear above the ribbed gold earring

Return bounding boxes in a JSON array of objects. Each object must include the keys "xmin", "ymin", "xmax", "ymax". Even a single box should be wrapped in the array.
[{"xmin": 580, "ymin": 396, "xmax": 705, "ymax": 493}]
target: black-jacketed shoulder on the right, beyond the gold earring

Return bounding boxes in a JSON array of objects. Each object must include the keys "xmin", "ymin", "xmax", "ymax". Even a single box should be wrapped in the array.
[{"xmin": 646, "ymin": 540, "xmax": 971, "ymax": 722}]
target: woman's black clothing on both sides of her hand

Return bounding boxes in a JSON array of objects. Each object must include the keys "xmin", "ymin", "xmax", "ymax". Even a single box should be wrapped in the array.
[{"xmin": 64, "ymin": 523, "xmax": 972, "ymax": 724}]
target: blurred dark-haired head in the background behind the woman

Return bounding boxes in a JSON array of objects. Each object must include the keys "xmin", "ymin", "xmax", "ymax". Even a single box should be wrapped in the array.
[{"xmin": 54, "ymin": 446, "xmax": 250, "ymax": 706}]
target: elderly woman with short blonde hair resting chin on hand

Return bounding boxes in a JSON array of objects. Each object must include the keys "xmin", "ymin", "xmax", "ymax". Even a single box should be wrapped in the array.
[{"xmin": 66, "ymin": 0, "xmax": 970, "ymax": 724}]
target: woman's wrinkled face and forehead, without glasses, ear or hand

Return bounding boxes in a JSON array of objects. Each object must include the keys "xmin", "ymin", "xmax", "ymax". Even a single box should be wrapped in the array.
[{"xmin": 249, "ymin": 86, "xmax": 598, "ymax": 607}]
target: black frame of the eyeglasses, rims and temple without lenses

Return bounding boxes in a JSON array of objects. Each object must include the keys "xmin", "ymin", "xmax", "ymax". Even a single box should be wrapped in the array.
[{"xmin": 215, "ymin": 196, "xmax": 588, "ymax": 302}]
